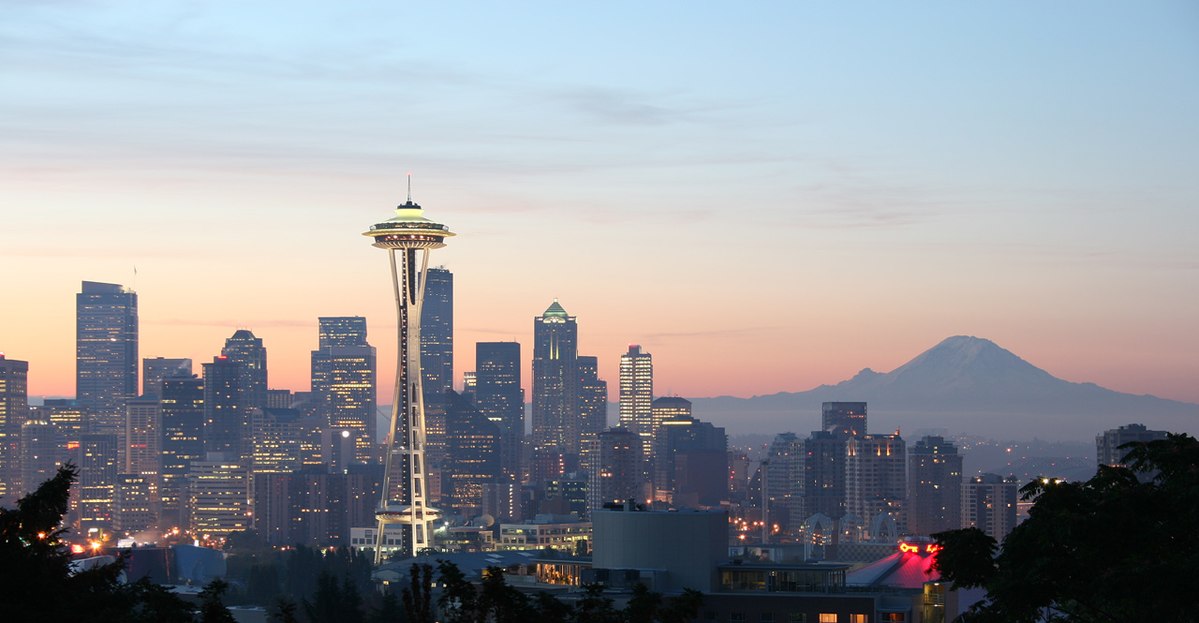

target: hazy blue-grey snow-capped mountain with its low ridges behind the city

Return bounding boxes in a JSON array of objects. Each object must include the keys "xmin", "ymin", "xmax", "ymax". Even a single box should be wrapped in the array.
[{"xmin": 691, "ymin": 335, "xmax": 1199, "ymax": 440}]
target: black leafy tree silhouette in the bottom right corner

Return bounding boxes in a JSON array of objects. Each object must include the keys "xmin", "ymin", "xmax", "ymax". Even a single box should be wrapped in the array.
[{"xmin": 934, "ymin": 435, "xmax": 1199, "ymax": 623}]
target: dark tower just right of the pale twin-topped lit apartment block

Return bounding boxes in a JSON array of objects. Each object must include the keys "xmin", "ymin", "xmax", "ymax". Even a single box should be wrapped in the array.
[{"xmin": 908, "ymin": 436, "xmax": 962, "ymax": 534}]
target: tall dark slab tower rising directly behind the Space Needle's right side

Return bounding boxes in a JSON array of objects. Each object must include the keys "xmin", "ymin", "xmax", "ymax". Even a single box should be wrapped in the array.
[{"xmin": 421, "ymin": 266, "xmax": 453, "ymax": 409}]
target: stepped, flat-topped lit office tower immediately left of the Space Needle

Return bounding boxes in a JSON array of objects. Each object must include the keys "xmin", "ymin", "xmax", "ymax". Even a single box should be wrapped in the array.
[{"xmin": 312, "ymin": 316, "xmax": 376, "ymax": 462}]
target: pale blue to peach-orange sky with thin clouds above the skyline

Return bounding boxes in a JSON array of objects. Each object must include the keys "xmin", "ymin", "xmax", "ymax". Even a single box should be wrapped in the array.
[{"xmin": 0, "ymin": 0, "xmax": 1199, "ymax": 403}]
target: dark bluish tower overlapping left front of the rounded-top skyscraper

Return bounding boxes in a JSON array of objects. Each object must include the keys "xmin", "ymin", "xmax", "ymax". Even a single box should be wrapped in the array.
[{"xmin": 203, "ymin": 355, "xmax": 249, "ymax": 461}]
